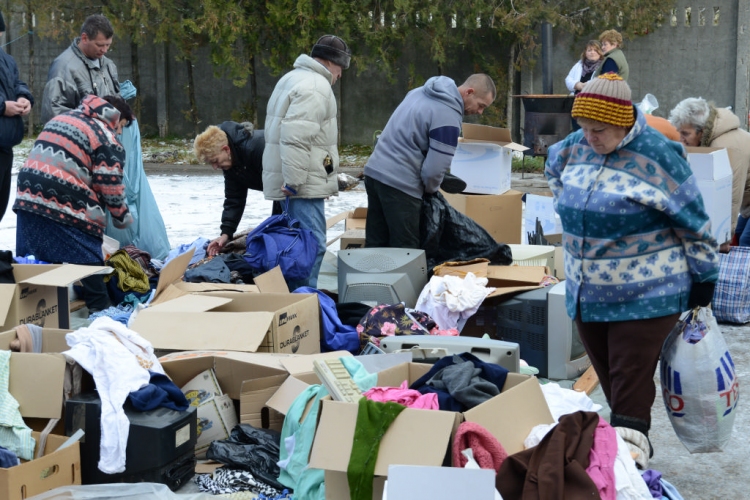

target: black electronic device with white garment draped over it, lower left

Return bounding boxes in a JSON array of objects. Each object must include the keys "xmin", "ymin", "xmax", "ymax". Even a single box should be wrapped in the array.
[{"xmin": 65, "ymin": 392, "xmax": 198, "ymax": 491}]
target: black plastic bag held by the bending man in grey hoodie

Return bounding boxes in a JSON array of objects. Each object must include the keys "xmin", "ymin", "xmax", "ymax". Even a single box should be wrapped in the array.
[{"xmin": 419, "ymin": 192, "xmax": 513, "ymax": 271}]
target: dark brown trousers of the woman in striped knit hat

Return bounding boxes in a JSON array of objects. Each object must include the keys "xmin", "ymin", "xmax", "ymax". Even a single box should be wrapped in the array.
[{"xmin": 576, "ymin": 314, "xmax": 680, "ymax": 435}]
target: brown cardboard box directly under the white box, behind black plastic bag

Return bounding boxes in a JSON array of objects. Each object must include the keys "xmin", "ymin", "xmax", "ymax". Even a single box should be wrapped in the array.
[{"xmin": 441, "ymin": 189, "xmax": 523, "ymax": 244}]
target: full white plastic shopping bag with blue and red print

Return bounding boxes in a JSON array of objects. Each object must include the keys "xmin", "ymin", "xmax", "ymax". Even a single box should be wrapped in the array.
[{"xmin": 660, "ymin": 307, "xmax": 740, "ymax": 453}]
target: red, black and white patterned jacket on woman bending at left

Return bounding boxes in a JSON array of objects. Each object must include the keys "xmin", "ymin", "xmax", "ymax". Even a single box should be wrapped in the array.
[{"xmin": 13, "ymin": 95, "xmax": 132, "ymax": 238}]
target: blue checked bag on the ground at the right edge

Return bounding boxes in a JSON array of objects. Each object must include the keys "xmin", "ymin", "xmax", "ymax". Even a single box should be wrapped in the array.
[{"xmin": 711, "ymin": 247, "xmax": 750, "ymax": 324}]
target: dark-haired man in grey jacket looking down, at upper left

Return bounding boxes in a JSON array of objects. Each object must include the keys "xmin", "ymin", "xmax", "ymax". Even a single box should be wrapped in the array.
[{"xmin": 42, "ymin": 14, "xmax": 120, "ymax": 123}]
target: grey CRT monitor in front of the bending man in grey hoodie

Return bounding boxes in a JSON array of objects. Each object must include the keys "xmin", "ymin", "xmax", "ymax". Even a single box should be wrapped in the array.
[{"xmin": 338, "ymin": 248, "xmax": 427, "ymax": 308}]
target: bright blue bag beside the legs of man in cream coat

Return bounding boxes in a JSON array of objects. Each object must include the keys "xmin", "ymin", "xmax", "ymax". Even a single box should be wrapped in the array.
[{"xmin": 243, "ymin": 197, "xmax": 318, "ymax": 281}]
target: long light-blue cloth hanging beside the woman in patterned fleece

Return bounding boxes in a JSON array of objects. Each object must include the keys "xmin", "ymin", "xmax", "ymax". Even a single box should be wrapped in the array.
[{"xmin": 105, "ymin": 120, "xmax": 169, "ymax": 259}]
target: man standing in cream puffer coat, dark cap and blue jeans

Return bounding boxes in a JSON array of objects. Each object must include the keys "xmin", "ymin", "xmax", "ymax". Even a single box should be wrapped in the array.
[{"xmin": 263, "ymin": 35, "xmax": 351, "ymax": 290}]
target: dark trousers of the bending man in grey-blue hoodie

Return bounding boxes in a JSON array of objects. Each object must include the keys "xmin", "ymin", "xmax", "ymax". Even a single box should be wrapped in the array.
[{"xmin": 365, "ymin": 176, "xmax": 422, "ymax": 248}]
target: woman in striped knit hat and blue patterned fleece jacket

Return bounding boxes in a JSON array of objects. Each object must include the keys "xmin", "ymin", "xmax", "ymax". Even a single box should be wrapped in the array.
[{"xmin": 545, "ymin": 73, "xmax": 718, "ymax": 469}]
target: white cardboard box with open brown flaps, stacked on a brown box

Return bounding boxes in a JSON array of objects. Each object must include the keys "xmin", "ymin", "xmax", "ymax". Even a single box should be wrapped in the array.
[{"xmin": 450, "ymin": 123, "xmax": 529, "ymax": 194}]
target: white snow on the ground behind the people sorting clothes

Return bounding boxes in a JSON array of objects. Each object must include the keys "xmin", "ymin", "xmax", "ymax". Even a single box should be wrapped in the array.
[{"xmin": 0, "ymin": 174, "xmax": 367, "ymax": 255}]
